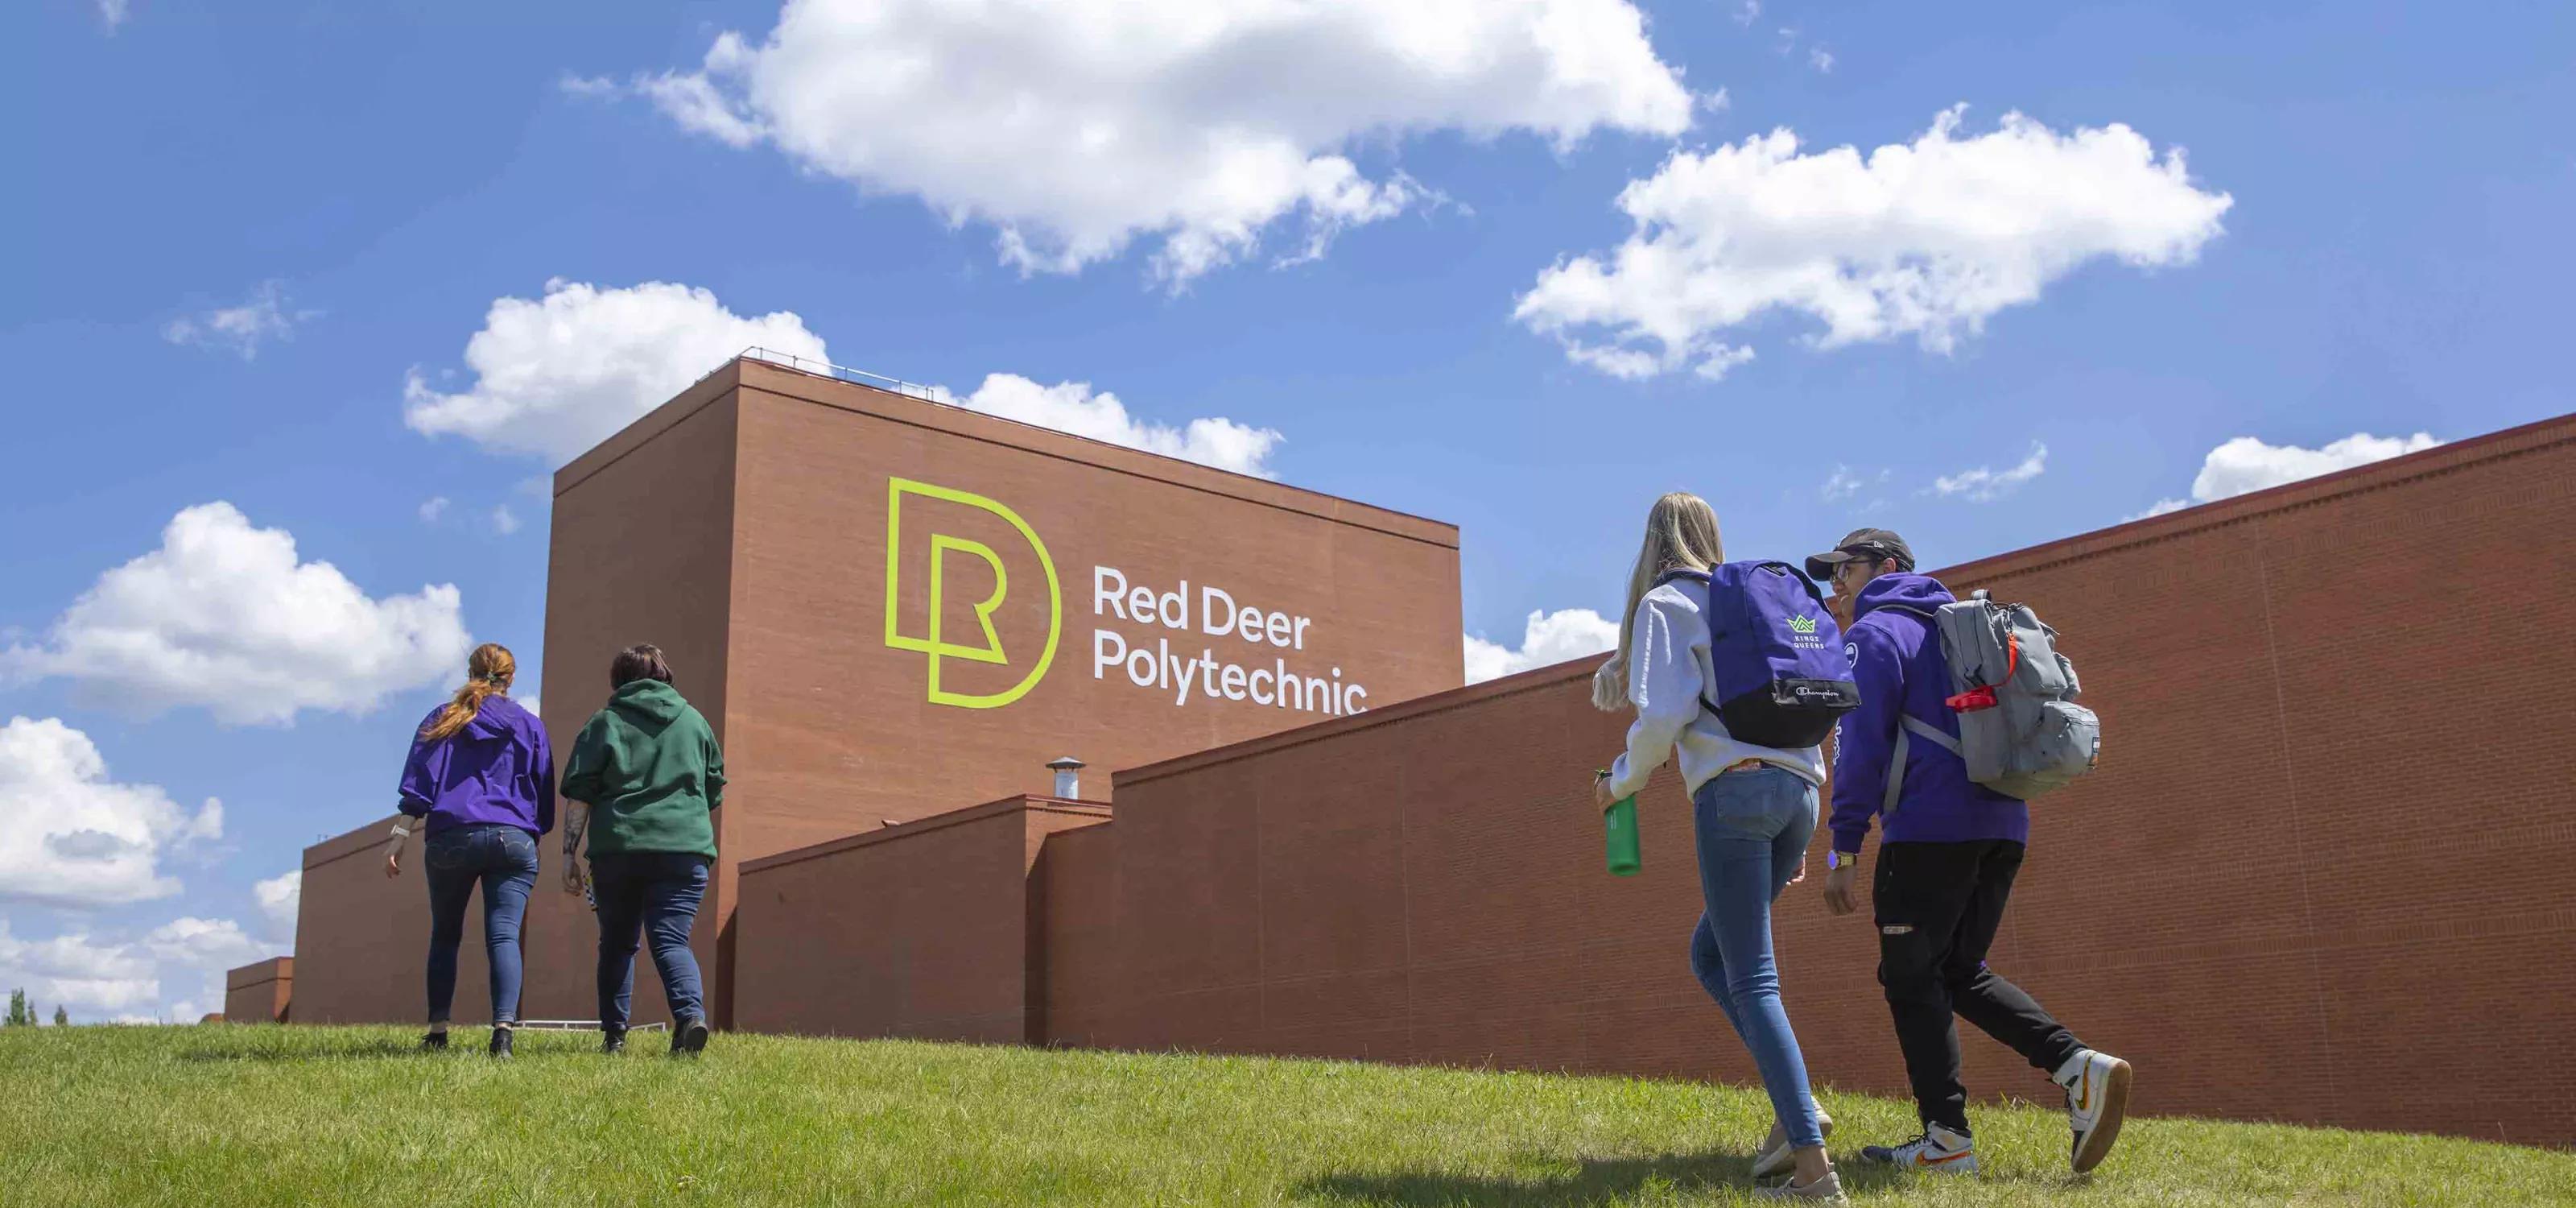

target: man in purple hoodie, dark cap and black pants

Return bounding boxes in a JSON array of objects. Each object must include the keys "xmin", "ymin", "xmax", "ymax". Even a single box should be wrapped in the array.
[{"xmin": 1806, "ymin": 528, "xmax": 2130, "ymax": 1174}]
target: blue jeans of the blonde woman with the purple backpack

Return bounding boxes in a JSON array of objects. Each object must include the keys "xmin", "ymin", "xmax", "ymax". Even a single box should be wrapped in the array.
[{"xmin": 1690, "ymin": 765, "xmax": 1824, "ymax": 1148}]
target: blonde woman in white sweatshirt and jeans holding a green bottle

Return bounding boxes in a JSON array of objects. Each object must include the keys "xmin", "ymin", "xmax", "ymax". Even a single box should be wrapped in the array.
[{"xmin": 1592, "ymin": 492, "xmax": 1842, "ymax": 1200}]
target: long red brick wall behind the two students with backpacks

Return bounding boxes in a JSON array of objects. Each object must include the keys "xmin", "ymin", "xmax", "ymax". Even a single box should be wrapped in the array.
[{"xmin": 1048, "ymin": 420, "xmax": 2576, "ymax": 1144}]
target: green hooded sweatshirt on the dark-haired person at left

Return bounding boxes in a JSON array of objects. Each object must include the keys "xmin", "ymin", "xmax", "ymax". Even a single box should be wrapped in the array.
[{"xmin": 564, "ymin": 680, "xmax": 724, "ymax": 860}]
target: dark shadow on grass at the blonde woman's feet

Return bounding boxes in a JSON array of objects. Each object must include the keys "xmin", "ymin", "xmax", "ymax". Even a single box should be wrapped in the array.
[{"xmin": 1296, "ymin": 1154, "xmax": 1896, "ymax": 1208}]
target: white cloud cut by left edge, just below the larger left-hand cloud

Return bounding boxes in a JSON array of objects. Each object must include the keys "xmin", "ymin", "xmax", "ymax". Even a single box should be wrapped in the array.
[{"xmin": 0, "ymin": 716, "xmax": 224, "ymax": 907}]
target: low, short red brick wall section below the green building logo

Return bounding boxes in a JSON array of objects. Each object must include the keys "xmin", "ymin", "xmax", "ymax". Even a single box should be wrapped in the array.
[{"xmin": 734, "ymin": 798, "xmax": 1108, "ymax": 1043}]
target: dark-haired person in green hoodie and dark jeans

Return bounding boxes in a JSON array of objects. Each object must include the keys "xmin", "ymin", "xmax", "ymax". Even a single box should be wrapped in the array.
[{"xmin": 562, "ymin": 647, "xmax": 724, "ymax": 1053}]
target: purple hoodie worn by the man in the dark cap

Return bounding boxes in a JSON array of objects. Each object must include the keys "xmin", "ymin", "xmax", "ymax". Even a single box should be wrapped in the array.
[{"xmin": 1834, "ymin": 574, "xmax": 2030, "ymax": 855}]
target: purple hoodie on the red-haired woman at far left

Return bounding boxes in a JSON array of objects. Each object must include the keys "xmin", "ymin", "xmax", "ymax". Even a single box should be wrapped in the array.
[{"xmin": 402, "ymin": 696, "xmax": 554, "ymax": 834}]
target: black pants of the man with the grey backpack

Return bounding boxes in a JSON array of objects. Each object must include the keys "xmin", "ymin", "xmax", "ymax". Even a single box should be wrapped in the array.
[{"xmin": 1872, "ymin": 840, "xmax": 2084, "ymax": 1133}]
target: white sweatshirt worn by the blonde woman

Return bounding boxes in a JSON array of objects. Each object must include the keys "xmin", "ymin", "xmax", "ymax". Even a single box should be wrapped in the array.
[{"xmin": 1610, "ymin": 580, "xmax": 1824, "ymax": 798}]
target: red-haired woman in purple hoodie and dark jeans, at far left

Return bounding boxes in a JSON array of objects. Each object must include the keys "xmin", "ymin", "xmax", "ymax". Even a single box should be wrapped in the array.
[{"xmin": 384, "ymin": 644, "xmax": 554, "ymax": 1056}]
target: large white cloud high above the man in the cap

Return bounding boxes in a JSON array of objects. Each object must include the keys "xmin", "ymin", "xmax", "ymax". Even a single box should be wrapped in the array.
[{"xmin": 1515, "ymin": 108, "xmax": 2233, "ymax": 381}]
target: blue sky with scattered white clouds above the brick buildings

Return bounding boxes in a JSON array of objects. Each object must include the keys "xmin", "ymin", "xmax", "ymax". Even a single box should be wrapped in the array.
[{"xmin": 0, "ymin": 0, "xmax": 2576, "ymax": 1017}]
